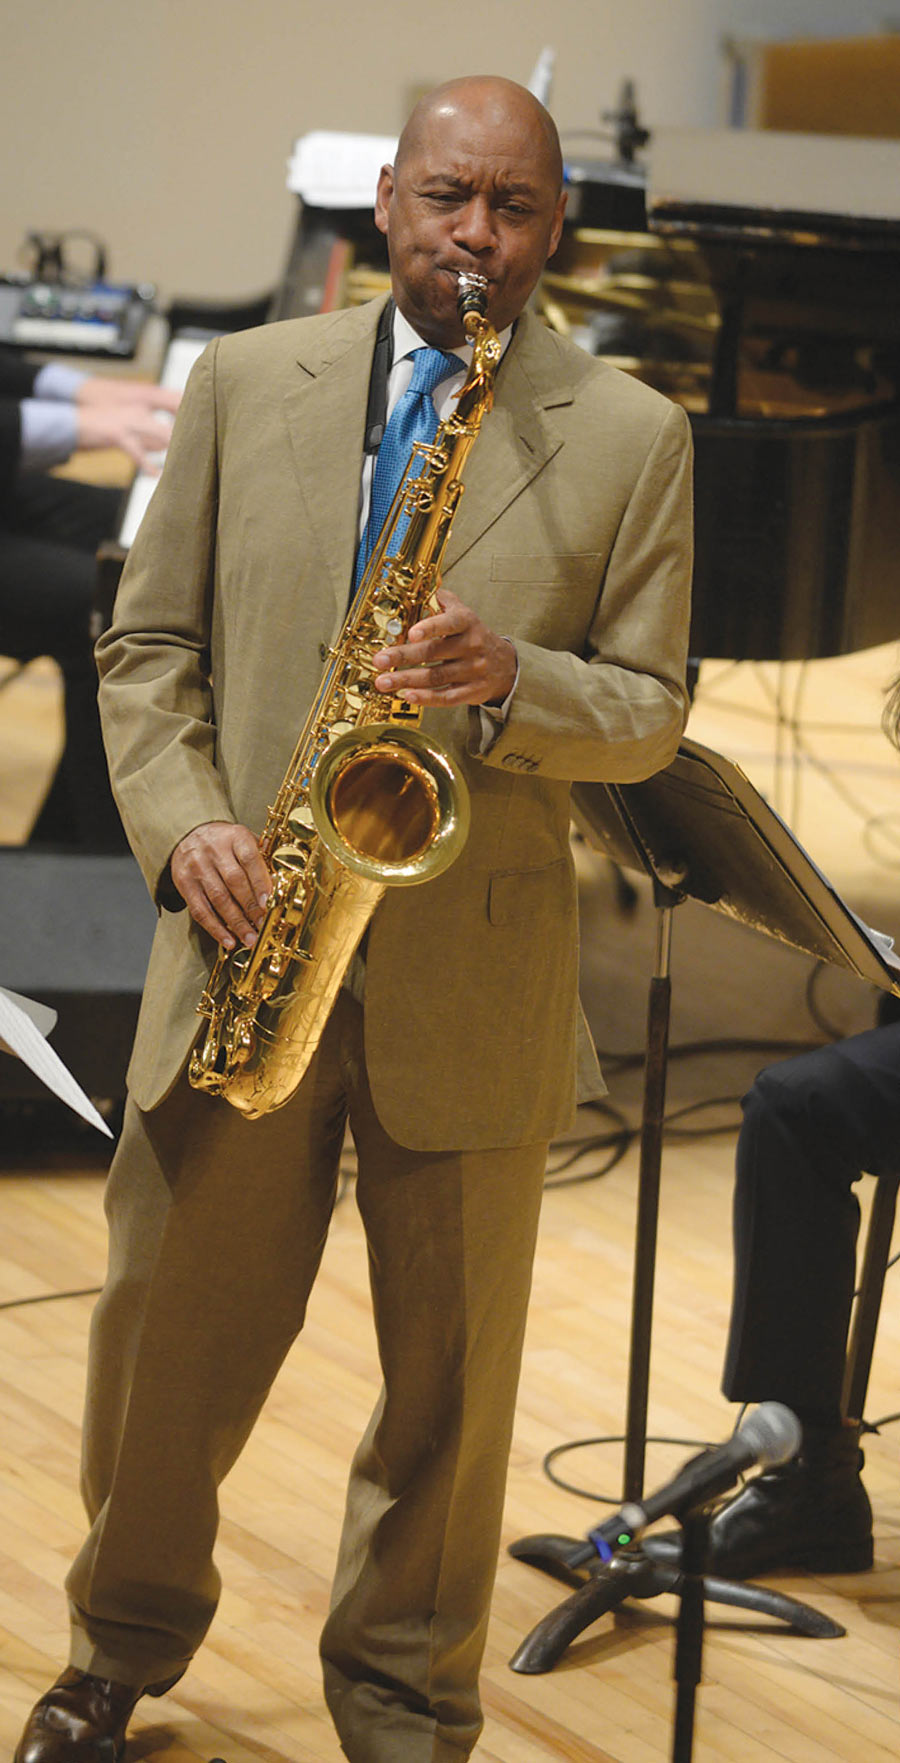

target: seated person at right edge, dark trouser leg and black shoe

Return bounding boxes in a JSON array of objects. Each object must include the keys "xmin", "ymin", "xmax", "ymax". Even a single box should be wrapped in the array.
[{"xmin": 648, "ymin": 679, "xmax": 900, "ymax": 1580}]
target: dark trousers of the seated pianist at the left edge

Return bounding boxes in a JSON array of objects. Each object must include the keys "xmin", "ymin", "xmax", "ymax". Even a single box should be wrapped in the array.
[{"xmin": 0, "ymin": 472, "xmax": 125, "ymax": 850}]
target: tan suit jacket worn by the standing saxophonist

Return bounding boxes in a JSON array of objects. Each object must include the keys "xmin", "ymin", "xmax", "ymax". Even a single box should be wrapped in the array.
[{"xmin": 97, "ymin": 301, "xmax": 692, "ymax": 1149}]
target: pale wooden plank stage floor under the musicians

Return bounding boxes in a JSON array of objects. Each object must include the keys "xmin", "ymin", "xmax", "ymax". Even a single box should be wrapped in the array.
[{"xmin": 0, "ymin": 631, "xmax": 900, "ymax": 1763}]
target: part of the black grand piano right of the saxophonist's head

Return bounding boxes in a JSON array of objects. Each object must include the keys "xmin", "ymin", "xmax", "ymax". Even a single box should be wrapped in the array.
[{"xmin": 544, "ymin": 129, "xmax": 900, "ymax": 661}]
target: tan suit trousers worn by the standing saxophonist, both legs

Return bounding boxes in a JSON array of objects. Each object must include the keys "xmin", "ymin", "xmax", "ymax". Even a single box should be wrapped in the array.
[{"xmin": 67, "ymin": 994, "xmax": 545, "ymax": 1763}]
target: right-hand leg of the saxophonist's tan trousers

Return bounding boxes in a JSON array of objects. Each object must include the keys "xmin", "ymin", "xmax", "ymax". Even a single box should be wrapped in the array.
[{"xmin": 321, "ymin": 1015, "xmax": 545, "ymax": 1763}]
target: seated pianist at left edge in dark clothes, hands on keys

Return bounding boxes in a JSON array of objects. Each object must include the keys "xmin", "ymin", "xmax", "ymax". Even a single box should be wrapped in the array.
[{"xmin": 0, "ymin": 351, "xmax": 178, "ymax": 850}]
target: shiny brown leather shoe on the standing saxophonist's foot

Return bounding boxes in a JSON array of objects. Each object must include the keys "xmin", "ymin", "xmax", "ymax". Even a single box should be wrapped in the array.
[{"xmin": 12, "ymin": 1666, "xmax": 182, "ymax": 1763}]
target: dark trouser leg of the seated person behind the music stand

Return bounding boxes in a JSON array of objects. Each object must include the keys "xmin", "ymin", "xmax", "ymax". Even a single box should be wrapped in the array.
[{"xmin": 724, "ymin": 1023, "xmax": 900, "ymax": 1416}]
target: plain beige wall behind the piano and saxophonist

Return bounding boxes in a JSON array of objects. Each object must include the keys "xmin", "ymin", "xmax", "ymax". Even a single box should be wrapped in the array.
[{"xmin": 0, "ymin": 0, "xmax": 884, "ymax": 308}]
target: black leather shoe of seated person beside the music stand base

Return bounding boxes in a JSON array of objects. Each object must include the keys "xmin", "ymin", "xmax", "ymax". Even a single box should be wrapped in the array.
[{"xmin": 642, "ymin": 1426, "xmax": 872, "ymax": 1580}]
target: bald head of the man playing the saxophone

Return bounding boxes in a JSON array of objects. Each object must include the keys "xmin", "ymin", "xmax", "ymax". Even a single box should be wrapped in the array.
[{"xmin": 376, "ymin": 74, "xmax": 565, "ymax": 347}]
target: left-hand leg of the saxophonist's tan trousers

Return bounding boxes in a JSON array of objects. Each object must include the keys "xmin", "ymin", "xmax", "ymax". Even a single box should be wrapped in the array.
[{"xmin": 67, "ymin": 1012, "xmax": 346, "ymax": 1684}]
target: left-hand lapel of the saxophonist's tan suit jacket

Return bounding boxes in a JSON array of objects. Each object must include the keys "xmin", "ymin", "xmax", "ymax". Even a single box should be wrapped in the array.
[{"xmin": 277, "ymin": 300, "xmax": 383, "ymax": 619}]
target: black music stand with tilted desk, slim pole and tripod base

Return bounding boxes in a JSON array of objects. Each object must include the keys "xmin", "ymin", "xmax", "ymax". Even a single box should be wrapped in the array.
[{"xmin": 510, "ymin": 740, "xmax": 900, "ymax": 1673}]
